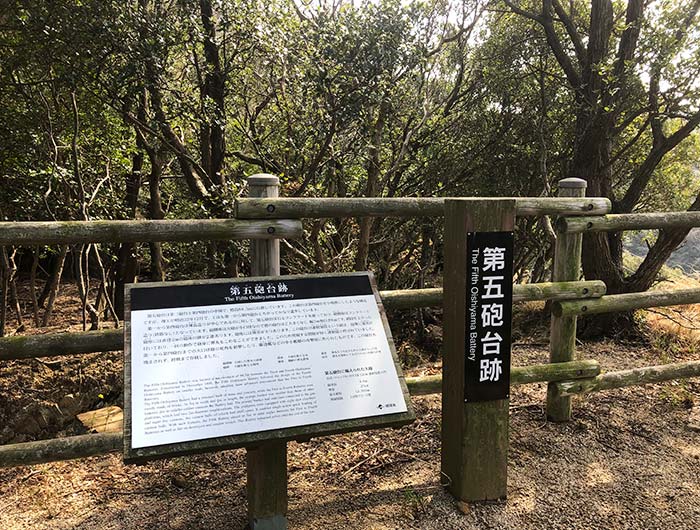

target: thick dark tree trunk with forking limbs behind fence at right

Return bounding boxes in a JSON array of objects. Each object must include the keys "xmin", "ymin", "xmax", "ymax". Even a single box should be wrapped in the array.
[{"xmin": 504, "ymin": 0, "xmax": 700, "ymax": 330}]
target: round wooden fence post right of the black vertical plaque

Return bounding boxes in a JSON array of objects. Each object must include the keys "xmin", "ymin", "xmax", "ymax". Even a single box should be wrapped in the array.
[{"xmin": 547, "ymin": 178, "xmax": 586, "ymax": 421}]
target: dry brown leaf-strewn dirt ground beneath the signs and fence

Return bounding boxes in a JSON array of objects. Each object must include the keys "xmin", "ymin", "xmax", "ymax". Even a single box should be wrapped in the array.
[{"xmin": 0, "ymin": 286, "xmax": 700, "ymax": 530}]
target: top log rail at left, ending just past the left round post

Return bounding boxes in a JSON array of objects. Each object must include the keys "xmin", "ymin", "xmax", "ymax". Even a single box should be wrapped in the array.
[{"xmin": 0, "ymin": 219, "xmax": 303, "ymax": 246}]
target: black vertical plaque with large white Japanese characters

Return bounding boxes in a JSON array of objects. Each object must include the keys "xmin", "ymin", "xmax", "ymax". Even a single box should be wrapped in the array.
[{"xmin": 464, "ymin": 232, "xmax": 513, "ymax": 403}]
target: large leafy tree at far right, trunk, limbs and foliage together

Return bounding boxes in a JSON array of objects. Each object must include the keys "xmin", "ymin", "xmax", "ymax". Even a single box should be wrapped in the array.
[{"xmin": 505, "ymin": 0, "xmax": 700, "ymax": 293}]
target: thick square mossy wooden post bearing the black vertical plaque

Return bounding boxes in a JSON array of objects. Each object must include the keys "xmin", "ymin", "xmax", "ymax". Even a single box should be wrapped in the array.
[{"xmin": 441, "ymin": 199, "xmax": 515, "ymax": 502}]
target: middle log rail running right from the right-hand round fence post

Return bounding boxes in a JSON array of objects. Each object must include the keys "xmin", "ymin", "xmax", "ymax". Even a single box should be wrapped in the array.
[{"xmin": 552, "ymin": 288, "xmax": 700, "ymax": 316}]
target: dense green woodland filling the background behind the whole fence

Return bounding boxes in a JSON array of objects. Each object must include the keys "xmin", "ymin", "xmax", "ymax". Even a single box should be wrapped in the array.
[{"xmin": 0, "ymin": 0, "xmax": 700, "ymax": 330}]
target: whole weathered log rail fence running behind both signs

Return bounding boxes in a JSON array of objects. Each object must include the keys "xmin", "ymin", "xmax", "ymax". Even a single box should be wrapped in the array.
[{"xmin": 0, "ymin": 176, "xmax": 700, "ymax": 520}]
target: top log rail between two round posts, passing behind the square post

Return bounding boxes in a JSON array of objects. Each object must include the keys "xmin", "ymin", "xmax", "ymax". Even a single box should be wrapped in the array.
[{"xmin": 236, "ymin": 197, "xmax": 612, "ymax": 219}]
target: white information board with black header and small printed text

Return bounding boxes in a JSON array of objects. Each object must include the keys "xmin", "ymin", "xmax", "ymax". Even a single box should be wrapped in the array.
[{"xmin": 130, "ymin": 275, "xmax": 407, "ymax": 449}]
